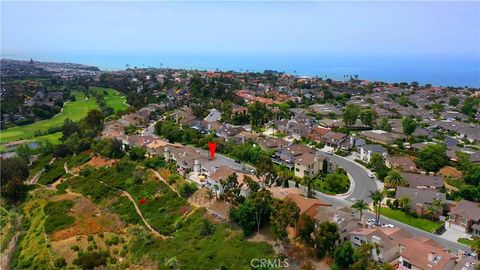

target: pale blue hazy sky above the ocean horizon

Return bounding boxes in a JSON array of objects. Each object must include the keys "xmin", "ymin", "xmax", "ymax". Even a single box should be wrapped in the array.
[{"xmin": 1, "ymin": 1, "xmax": 480, "ymax": 58}]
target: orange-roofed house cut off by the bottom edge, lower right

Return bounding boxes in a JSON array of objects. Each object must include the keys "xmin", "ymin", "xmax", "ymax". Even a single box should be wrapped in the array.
[{"xmin": 397, "ymin": 238, "xmax": 457, "ymax": 270}]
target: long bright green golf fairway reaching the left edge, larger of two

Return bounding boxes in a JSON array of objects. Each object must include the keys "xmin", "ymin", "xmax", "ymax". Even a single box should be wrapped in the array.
[{"xmin": 0, "ymin": 92, "xmax": 98, "ymax": 143}]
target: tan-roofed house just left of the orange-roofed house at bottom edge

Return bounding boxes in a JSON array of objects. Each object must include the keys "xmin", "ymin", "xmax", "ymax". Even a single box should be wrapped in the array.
[{"xmin": 349, "ymin": 227, "xmax": 412, "ymax": 263}]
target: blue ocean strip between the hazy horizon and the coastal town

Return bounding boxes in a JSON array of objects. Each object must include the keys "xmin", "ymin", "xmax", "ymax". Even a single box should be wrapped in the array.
[{"xmin": 2, "ymin": 54, "xmax": 480, "ymax": 87}]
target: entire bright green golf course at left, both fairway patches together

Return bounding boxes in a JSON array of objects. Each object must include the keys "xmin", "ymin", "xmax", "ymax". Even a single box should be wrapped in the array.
[{"xmin": 0, "ymin": 87, "xmax": 128, "ymax": 143}]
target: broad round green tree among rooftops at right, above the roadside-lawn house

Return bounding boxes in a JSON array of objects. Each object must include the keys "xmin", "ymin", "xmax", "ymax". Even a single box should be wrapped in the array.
[{"xmin": 417, "ymin": 144, "xmax": 447, "ymax": 172}]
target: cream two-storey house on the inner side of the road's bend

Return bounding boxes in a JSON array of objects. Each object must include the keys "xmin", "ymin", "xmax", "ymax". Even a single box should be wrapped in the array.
[{"xmin": 294, "ymin": 153, "xmax": 334, "ymax": 178}]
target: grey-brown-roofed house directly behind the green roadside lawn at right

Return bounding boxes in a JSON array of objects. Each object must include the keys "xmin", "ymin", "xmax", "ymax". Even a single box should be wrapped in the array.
[{"xmin": 395, "ymin": 187, "xmax": 447, "ymax": 216}]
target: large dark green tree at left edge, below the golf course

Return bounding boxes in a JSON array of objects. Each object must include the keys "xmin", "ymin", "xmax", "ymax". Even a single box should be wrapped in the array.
[{"xmin": 0, "ymin": 157, "xmax": 29, "ymax": 203}]
